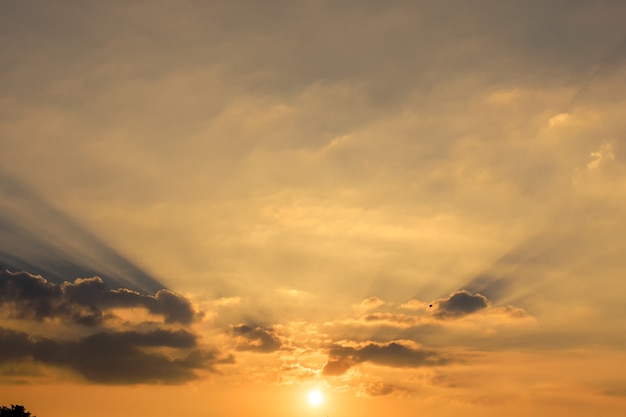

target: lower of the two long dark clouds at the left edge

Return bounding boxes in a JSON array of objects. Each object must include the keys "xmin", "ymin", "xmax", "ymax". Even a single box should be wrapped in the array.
[{"xmin": 0, "ymin": 328, "xmax": 233, "ymax": 384}]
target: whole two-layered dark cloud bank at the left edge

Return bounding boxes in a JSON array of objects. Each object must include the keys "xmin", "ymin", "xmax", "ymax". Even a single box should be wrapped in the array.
[{"xmin": 0, "ymin": 271, "xmax": 234, "ymax": 384}]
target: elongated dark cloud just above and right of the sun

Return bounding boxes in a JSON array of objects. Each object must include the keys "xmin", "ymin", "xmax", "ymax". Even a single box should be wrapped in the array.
[{"xmin": 322, "ymin": 342, "xmax": 451, "ymax": 376}]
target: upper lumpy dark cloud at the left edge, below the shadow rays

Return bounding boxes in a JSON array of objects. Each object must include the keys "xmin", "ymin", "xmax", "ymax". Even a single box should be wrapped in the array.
[{"xmin": 0, "ymin": 270, "xmax": 197, "ymax": 326}]
